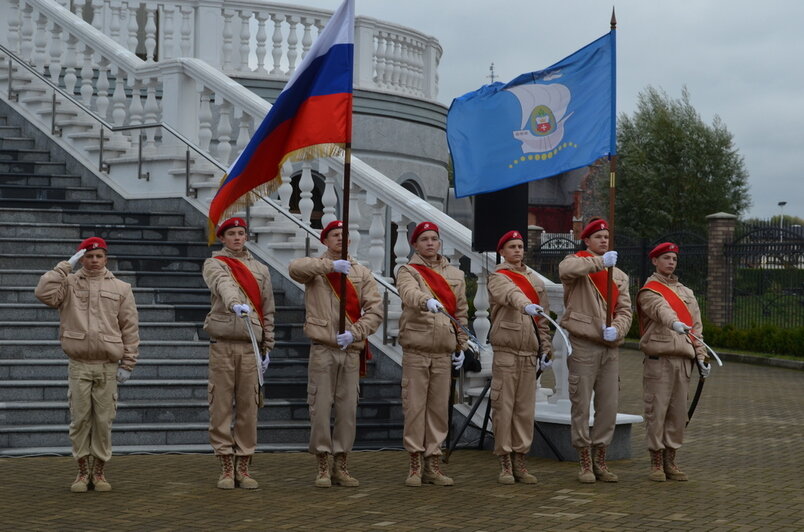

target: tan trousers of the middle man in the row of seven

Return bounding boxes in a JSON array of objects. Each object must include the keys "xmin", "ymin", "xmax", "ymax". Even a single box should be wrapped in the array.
[{"xmin": 402, "ymin": 353, "xmax": 452, "ymax": 456}]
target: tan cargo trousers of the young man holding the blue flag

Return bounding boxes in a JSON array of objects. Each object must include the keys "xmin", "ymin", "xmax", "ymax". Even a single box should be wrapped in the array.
[{"xmin": 567, "ymin": 337, "xmax": 620, "ymax": 449}]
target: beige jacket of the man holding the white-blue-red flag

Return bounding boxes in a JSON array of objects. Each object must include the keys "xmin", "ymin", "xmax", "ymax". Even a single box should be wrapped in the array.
[{"xmin": 288, "ymin": 250, "xmax": 382, "ymax": 351}]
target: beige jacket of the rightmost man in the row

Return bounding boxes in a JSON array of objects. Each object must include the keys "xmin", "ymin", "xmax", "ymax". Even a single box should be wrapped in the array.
[{"xmin": 637, "ymin": 273, "xmax": 707, "ymax": 358}]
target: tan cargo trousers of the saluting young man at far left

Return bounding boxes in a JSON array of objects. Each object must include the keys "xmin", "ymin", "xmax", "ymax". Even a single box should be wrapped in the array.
[{"xmin": 67, "ymin": 360, "xmax": 118, "ymax": 462}]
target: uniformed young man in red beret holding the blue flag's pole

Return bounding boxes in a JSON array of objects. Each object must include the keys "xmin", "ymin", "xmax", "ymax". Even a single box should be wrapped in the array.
[{"xmin": 558, "ymin": 218, "xmax": 632, "ymax": 483}]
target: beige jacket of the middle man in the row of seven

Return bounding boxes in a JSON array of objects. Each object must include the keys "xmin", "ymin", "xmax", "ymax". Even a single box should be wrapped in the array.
[{"xmin": 396, "ymin": 253, "xmax": 469, "ymax": 354}]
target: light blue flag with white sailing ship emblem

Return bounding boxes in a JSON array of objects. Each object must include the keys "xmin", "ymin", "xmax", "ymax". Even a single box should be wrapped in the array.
[{"xmin": 447, "ymin": 30, "xmax": 617, "ymax": 197}]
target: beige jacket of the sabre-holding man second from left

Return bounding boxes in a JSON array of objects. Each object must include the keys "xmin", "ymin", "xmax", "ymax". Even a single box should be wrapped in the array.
[{"xmin": 203, "ymin": 247, "xmax": 275, "ymax": 353}]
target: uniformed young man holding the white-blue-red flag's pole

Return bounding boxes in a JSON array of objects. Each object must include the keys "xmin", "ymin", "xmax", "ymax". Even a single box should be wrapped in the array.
[{"xmin": 289, "ymin": 220, "xmax": 382, "ymax": 488}]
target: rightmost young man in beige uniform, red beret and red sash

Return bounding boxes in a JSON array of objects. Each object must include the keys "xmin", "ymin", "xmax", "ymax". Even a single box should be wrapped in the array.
[{"xmin": 637, "ymin": 242, "xmax": 709, "ymax": 482}]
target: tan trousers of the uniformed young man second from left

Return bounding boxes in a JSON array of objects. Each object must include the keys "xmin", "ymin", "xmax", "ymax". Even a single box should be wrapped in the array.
[{"xmin": 207, "ymin": 340, "xmax": 262, "ymax": 456}]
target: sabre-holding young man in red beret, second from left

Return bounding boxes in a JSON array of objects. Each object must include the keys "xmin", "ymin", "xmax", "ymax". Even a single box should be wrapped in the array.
[{"xmin": 203, "ymin": 218, "xmax": 274, "ymax": 489}]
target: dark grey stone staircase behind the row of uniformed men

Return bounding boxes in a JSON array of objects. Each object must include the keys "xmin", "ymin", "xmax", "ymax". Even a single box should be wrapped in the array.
[{"xmin": 0, "ymin": 116, "xmax": 402, "ymax": 456}]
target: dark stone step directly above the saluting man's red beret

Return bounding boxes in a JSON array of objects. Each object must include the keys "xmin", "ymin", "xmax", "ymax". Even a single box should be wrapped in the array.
[{"xmin": 0, "ymin": 221, "xmax": 206, "ymax": 242}]
